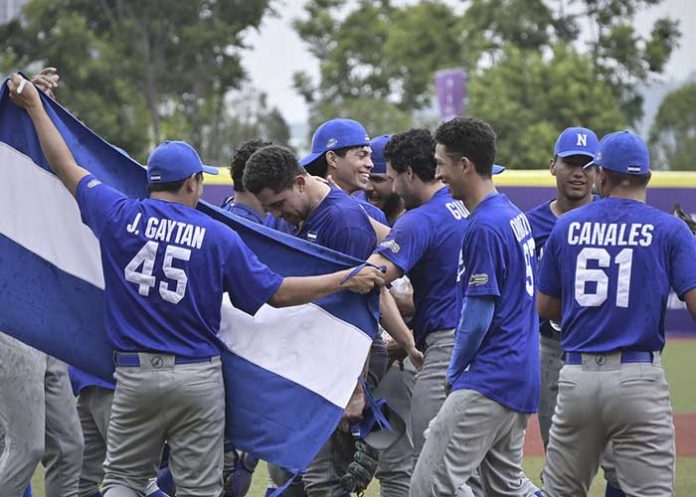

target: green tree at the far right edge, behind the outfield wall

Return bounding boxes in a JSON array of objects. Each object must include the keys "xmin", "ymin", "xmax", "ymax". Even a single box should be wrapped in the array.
[{"xmin": 649, "ymin": 83, "xmax": 696, "ymax": 171}]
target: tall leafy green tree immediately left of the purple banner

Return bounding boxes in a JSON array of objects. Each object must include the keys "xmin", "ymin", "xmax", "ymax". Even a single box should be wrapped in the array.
[{"xmin": 294, "ymin": 0, "xmax": 466, "ymax": 133}]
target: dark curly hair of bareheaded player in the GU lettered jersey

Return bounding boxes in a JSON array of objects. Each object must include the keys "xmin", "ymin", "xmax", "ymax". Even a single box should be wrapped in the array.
[{"xmin": 384, "ymin": 128, "xmax": 437, "ymax": 183}]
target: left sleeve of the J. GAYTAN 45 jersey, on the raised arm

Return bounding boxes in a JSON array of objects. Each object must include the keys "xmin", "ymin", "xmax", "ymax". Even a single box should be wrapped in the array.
[{"xmin": 75, "ymin": 174, "xmax": 128, "ymax": 238}]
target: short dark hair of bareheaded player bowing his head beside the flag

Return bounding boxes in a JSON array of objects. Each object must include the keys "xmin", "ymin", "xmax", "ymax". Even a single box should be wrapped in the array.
[{"xmin": 244, "ymin": 145, "xmax": 307, "ymax": 194}]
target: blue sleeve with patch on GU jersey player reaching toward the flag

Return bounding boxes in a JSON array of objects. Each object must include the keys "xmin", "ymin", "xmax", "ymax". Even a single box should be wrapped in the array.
[{"xmin": 375, "ymin": 213, "xmax": 430, "ymax": 273}]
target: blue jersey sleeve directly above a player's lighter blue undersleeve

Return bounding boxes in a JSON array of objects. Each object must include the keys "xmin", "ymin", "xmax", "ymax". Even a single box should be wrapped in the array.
[{"xmin": 461, "ymin": 226, "xmax": 506, "ymax": 298}]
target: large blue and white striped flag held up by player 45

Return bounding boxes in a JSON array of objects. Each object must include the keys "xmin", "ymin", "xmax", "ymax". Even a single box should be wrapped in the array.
[{"xmin": 0, "ymin": 82, "xmax": 378, "ymax": 470}]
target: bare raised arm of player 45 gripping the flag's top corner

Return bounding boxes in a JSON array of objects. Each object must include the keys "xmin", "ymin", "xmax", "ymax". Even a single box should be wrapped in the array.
[{"xmin": 7, "ymin": 74, "xmax": 89, "ymax": 196}]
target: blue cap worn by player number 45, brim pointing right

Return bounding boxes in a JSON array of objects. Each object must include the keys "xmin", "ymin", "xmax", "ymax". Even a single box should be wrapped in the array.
[{"xmin": 147, "ymin": 140, "xmax": 219, "ymax": 183}]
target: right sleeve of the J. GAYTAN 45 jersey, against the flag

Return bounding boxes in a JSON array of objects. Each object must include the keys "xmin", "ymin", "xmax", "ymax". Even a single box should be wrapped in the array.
[{"xmin": 224, "ymin": 230, "xmax": 283, "ymax": 316}]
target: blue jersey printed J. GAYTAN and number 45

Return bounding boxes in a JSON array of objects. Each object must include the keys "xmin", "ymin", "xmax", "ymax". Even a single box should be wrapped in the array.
[{"xmin": 76, "ymin": 175, "xmax": 282, "ymax": 358}]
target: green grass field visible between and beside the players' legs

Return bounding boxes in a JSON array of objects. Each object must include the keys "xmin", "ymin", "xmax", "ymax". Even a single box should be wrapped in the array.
[{"xmin": 32, "ymin": 340, "xmax": 696, "ymax": 497}]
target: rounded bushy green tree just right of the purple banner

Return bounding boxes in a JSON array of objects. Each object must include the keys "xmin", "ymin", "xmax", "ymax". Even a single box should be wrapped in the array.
[{"xmin": 469, "ymin": 44, "xmax": 626, "ymax": 169}]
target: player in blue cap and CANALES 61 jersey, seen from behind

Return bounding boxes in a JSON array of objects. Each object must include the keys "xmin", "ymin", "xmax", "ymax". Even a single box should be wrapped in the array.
[{"xmin": 538, "ymin": 131, "xmax": 696, "ymax": 497}]
